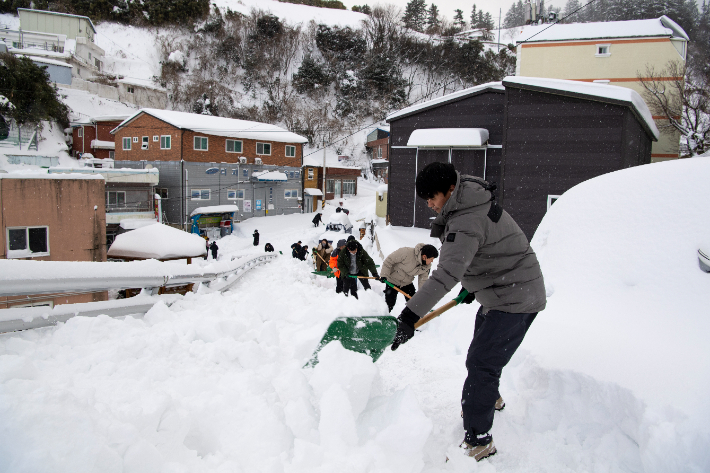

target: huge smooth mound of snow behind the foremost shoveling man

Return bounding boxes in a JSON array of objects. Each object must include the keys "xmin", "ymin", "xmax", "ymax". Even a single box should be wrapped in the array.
[{"xmin": 526, "ymin": 158, "xmax": 710, "ymax": 471}]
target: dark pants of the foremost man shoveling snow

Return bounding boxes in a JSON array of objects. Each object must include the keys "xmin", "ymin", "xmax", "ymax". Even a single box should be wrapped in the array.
[{"xmin": 461, "ymin": 307, "xmax": 537, "ymax": 443}]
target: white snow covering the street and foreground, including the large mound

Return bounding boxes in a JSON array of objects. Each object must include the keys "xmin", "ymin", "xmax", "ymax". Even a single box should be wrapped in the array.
[{"xmin": 0, "ymin": 158, "xmax": 710, "ymax": 473}]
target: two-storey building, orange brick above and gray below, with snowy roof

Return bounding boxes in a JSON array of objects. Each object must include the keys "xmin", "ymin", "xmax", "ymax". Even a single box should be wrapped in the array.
[{"xmin": 112, "ymin": 109, "xmax": 308, "ymax": 228}]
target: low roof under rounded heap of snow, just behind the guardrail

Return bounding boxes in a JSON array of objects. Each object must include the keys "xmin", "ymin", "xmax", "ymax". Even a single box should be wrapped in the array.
[{"xmin": 107, "ymin": 223, "xmax": 207, "ymax": 260}]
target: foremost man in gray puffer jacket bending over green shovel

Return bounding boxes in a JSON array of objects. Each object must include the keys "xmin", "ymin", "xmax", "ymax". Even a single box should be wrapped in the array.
[{"xmin": 392, "ymin": 162, "xmax": 546, "ymax": 460}]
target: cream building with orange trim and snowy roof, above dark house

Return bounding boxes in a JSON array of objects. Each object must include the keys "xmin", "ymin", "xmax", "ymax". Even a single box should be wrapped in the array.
[{"xmin": 516, "ymin": 16, "xmax": 688, "ymax": 162}]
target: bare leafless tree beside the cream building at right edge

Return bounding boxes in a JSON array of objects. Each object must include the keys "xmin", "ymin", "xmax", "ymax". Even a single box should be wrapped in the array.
[{"xmin": 637, "ymin": 57, "xmax": 710, "ymax": 156}]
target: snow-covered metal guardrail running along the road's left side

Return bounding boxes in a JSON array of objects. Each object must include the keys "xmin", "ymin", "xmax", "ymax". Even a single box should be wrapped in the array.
[{"xmin": 0, "ymin": 253, "xmax": 278, "ymax": 333}]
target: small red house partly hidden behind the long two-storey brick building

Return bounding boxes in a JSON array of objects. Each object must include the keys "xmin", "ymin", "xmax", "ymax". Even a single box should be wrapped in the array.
[{"xmin": 71, "ymin": 115, "xmax": 128, "ymax": 159}]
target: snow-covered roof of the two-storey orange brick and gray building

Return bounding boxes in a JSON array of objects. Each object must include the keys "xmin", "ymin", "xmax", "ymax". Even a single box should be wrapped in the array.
[{"xmin": 111, "ymin": 108, "xmax": 308, "ymax": 143}]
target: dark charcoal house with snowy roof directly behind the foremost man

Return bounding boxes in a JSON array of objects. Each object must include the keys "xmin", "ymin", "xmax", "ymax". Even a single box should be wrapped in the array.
[{"xmin": 387, "ymin": 76, "xmax": 658, "ymax": 238}]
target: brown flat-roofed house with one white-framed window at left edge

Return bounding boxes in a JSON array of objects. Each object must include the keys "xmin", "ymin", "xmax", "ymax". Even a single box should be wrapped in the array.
[{"xmin": 0, "ymin": 173, "xmax": 107, "ymax": 308}]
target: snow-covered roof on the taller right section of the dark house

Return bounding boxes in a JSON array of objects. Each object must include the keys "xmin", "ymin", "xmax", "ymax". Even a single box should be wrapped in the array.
[{"xmin": 503, "ymin": 76, "xmax": 659, "ymax": 141}]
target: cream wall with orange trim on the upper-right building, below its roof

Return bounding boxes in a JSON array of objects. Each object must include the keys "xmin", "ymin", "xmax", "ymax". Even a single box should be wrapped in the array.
[{"xmin": 518, "ymin": 38, "xmax": 685, "ymax": 161}]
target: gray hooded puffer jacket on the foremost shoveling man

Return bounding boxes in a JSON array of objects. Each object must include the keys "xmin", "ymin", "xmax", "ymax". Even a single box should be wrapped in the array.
[{"xmin": 407, "ymin": 172, "xmax": 547, "ymax": 317}]
